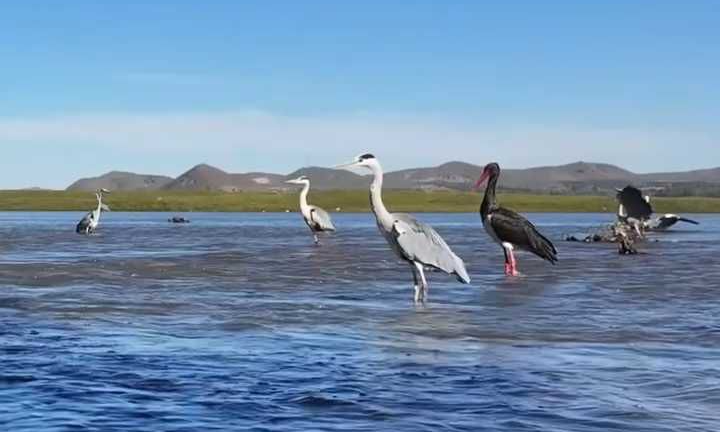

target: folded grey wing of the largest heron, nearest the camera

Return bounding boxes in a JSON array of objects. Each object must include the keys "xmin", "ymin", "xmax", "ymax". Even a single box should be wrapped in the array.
[{"xmin": 392, "ymin": 213, "xmax": 470, "ymax": 283}]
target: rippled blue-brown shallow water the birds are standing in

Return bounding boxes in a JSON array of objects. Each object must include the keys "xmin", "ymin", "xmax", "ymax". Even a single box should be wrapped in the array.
[{"xmin": 0, "ymin": 213, "xmax": 720, "ymax": 432}]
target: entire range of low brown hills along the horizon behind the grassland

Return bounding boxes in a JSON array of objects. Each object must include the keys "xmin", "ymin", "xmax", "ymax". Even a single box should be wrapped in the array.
[{"xmin": 68, "ymin": 162, "xmax": 720, "ymax": 196}]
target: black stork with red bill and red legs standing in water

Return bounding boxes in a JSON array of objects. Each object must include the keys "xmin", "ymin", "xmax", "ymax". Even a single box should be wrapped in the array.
[{"xmin": 475, "ymin": 162, "xmax": 558, "ymax": 276}]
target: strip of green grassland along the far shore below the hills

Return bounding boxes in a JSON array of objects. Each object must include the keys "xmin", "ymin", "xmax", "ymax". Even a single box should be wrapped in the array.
[{"xmin": 0, "ymin": 190, "xmax": 720, "ymax": 213}]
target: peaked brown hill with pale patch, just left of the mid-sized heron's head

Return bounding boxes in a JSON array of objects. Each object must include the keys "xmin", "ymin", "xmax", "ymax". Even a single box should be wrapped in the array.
[{"xmin": 163, "ymin": 164, "xmax": 285, "ymax": 192}]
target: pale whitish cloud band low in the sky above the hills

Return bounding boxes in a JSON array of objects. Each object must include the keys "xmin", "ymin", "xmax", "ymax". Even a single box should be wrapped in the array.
[{"xmin": 0, "ymin": 111, "xmax": 718, "ymax": 171}]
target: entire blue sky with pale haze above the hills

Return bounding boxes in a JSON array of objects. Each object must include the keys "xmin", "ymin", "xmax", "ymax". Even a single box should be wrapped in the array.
[{"xmin": 0, "ymin": 0, "xmax": 720, "ymax": 188}]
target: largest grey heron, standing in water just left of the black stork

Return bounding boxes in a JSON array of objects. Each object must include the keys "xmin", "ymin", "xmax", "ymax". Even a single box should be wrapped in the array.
[{"xmin": 336, "ymin": 153, "xmax": 470, "ymax": 303}]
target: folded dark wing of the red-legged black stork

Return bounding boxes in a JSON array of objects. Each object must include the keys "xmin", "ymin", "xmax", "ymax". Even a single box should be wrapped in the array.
[{"xmin": 490, "ymin": 207, "xmax": 558, "ymax": 264}]
